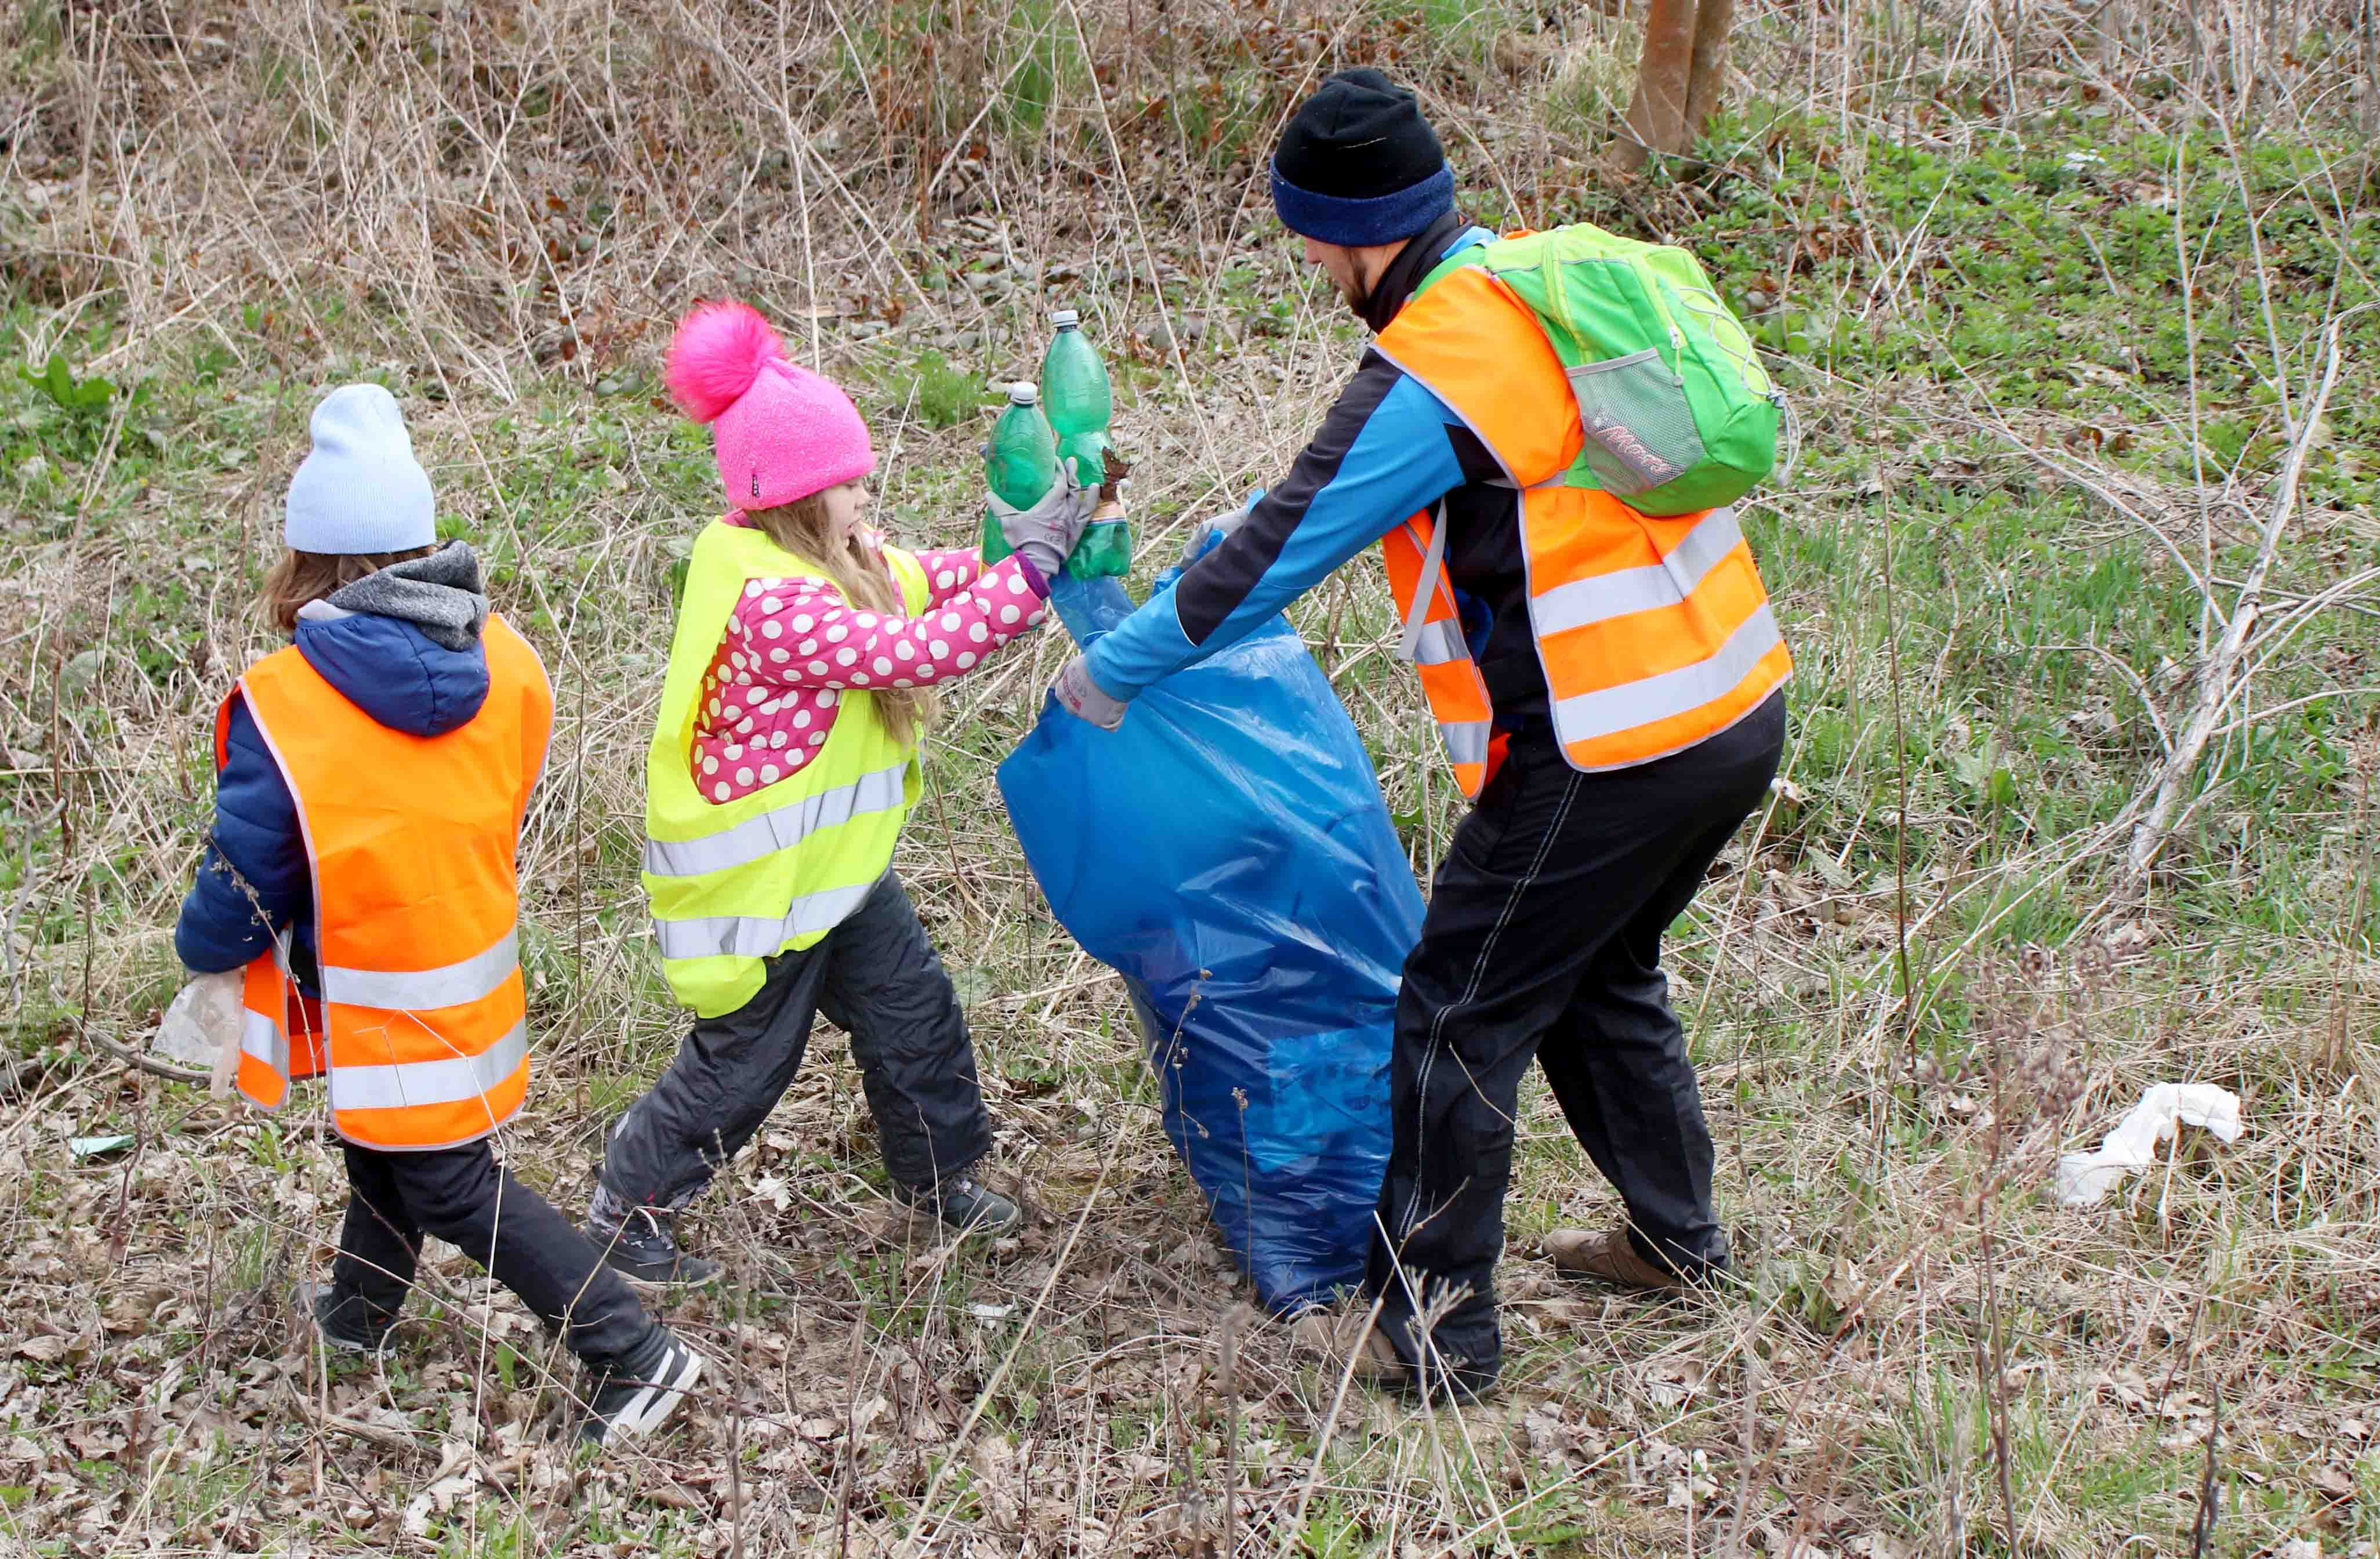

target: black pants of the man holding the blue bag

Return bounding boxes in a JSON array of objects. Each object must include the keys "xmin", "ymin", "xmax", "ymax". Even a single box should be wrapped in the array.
[{"xmin": 1366, "ymin": 693, "xmax": 1785, "ymax": 1390}]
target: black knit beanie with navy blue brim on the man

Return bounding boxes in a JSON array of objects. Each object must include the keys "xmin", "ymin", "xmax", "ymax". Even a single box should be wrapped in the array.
[{"xmin": 1274, "ymin": 69, "xmax": 1454, "ymax": 248}]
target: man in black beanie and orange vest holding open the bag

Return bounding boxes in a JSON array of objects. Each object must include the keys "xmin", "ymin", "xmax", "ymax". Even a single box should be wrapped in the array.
[{"xmin": 1054, "ymin": 71, "xmax": 1790, "ymax": 1395}]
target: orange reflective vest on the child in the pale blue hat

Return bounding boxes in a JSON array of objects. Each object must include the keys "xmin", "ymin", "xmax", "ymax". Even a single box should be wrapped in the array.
[{"xmin": 214, "ymin": 617, "xmax": 554, "ymax": 1150}]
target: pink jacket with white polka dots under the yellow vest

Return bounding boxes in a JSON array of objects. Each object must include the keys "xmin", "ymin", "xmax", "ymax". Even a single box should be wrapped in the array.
[{"xmin": 688, "ymin": 517, "xmax": 1050, "ymax": 802}]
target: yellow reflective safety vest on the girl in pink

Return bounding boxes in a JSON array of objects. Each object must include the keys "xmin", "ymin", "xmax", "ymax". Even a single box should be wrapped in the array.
[{"xmin": 645, "ymin": 521, "xmax": 931, "ymax": 1018}]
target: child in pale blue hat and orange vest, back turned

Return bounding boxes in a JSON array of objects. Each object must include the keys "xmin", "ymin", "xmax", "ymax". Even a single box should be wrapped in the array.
[{"xmin": 174, "ymin": 386, "xmax": 702, "ymax": 1442}]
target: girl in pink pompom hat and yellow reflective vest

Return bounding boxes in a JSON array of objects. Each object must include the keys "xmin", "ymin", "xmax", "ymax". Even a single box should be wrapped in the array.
[{"xmin": 588, "ymin": 302, "xmax": 1093, "ymax": 1283}]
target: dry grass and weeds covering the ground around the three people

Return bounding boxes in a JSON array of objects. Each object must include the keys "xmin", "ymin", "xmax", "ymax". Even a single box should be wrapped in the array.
[{"xmin": 0, "ymin": 0, "xmax": 2380, "ymax": 1557}]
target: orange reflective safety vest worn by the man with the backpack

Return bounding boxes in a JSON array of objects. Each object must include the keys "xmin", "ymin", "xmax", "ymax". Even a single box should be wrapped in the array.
[{"xmin": 1378, "ymin": 267, "xmax": 1792, "ymax": 797}]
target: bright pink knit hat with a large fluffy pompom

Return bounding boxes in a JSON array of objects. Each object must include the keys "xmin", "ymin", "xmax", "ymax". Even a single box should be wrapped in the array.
[{"xmin": 669, "ymin": 302, "xmax": 876, "ymax": 509}]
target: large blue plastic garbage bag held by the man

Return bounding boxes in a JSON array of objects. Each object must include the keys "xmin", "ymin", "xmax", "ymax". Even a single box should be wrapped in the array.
[{"xmin": 1000, "ymin": 571, "xmax": 1421, "ymax": 1314}]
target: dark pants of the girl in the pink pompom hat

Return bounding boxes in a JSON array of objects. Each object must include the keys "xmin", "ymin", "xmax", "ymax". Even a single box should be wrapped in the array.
[{"xmin": 602, "ymin": 871, "xmax": 992, "ymax": 1209}]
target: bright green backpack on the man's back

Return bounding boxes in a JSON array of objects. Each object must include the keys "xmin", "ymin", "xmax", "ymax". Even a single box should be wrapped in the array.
[{"xmin": 1423, "ymin": 222, "xmax": 1783, "ymax": 514}]
